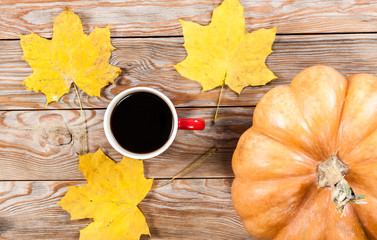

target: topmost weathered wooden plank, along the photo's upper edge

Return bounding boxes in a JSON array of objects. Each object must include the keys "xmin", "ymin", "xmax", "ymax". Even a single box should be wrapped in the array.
[{"xmin": 0, "ymin": 0, "xmax": 377, "ymax": 39}]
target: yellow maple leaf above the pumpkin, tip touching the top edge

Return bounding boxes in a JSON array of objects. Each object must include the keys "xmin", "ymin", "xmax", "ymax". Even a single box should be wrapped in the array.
[{"xmin": 175, "ymin": 0, "xmax": 276, "ymax": 94}]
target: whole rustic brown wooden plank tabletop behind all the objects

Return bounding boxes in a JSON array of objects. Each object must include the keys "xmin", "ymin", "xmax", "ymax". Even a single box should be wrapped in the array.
[{"xmin": 0, "ymin": 0, "xmax": 377, "ymax": 240}]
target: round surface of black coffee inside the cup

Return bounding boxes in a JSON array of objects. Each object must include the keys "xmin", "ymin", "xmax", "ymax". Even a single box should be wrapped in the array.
[{"xmin": 110, "ymin": 92, "xmax": 173, "ymax": 153}]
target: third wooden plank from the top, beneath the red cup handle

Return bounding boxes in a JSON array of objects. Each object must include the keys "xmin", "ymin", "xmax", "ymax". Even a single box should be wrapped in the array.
[{"xmin": 0, "ymin": 107, "xmax": 253, "ymax": 180}]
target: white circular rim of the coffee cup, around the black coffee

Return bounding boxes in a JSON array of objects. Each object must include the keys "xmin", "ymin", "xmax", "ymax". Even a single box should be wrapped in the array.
[{"xmin": 103, "ymin": 87, "xmax": 178, "ymax": 159}]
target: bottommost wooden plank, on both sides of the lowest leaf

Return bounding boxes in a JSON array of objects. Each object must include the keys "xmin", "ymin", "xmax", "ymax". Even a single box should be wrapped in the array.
[{"xmin": 0, "ymin": 179, "xmax": 253, "ymax": 240}]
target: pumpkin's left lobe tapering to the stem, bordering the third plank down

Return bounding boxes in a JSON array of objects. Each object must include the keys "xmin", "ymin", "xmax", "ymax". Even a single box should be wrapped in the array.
[{"xmin": 232, "ymin": 127, "xmax": 316, "ymax": 179}]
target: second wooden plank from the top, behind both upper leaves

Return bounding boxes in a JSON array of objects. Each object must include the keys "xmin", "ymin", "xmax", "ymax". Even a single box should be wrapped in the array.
[{"xmin": 0, "ymin": 34, "xmax": 377, "ymax": 109}]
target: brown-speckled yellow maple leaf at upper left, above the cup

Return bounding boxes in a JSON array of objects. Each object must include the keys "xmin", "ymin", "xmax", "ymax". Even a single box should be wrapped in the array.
[{"xmin": 20, "ymin": 8, "xmax": 121, "ymax": 104}]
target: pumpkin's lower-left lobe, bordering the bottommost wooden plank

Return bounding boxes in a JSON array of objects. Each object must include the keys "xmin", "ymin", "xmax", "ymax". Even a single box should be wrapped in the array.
[{"xmin": 232, "ymin": 177, "xmax": 314, "ymax": 239}]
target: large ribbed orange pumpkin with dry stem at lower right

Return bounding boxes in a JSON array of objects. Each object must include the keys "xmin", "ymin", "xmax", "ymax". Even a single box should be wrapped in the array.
[{"xmin": 232, "ymin": 66, "xmax": 377, "ymax": 240}]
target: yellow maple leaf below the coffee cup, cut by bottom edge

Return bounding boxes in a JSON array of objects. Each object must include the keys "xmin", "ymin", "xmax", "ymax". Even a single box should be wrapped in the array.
[{"xmin": 58, "ymin": 149, "xmax": 153, "ymax": 240}]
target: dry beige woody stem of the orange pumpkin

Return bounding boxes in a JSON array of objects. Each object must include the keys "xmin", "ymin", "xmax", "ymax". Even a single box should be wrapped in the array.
[{"xmin": 317, "ymin": 153, "xmax": 365, "ymax": 213}]
